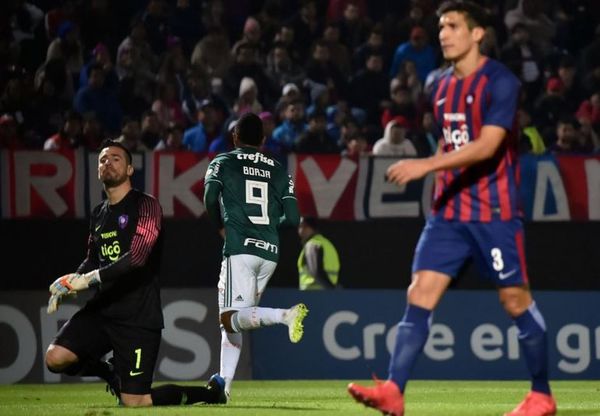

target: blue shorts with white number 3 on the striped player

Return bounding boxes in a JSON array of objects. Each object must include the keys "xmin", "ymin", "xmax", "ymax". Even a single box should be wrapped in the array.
[{"xmin": 412, "ymin": 217, "xmax": 529, "ymax": 286}]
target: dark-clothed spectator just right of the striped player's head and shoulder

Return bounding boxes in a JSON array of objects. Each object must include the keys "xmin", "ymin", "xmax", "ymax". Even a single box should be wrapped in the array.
[{"xmin": 500, "ymin": 23, "xmax": 544, "ymax": 104}]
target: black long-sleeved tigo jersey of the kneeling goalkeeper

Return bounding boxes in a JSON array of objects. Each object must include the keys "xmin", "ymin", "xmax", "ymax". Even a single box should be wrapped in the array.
[{"xmin": 77, "ymin": 189, "xmax": 163, "ymax": 328}]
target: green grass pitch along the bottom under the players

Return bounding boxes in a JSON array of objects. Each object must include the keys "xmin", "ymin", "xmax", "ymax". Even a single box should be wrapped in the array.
[{"xmin": 0, "ymin": 380, "xmax": 600, "ymax": 416}]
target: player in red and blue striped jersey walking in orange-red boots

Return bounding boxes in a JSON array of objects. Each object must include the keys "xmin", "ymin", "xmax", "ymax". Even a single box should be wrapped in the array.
[{"xmin": 348, "ymin": 0, "xmax": 556, "ymax": 416}]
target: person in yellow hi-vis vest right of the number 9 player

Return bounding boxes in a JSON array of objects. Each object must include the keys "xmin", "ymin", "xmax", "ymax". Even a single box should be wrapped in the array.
[{"xmin": 298, "ymin": 217, "xmax": 340, "ymax": 290}]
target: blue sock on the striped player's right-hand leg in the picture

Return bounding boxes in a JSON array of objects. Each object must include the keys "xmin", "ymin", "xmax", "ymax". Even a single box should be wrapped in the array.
[{"xmin": 514, "ymin": 302, "xmax": 550, "ymax": 394}]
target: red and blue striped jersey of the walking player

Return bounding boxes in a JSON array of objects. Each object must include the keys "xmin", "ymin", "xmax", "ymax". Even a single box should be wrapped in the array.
[{"xmin": 432, "ymin": 58, "xmax": 521, "ymax": 222}]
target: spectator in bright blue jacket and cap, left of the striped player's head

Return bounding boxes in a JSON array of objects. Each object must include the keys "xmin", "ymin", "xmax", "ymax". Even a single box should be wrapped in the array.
[{"xmin": 390, "ymin": 26, "xmax": 437, "ymax": 84}]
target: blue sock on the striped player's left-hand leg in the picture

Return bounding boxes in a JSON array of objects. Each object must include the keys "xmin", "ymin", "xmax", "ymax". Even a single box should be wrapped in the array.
[{"xmin": 389, "ymin": 304, "xmax": 431, "ymax": 392}]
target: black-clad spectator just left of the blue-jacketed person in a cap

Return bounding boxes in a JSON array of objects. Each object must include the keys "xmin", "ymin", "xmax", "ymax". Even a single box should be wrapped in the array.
[{"xmin": 348, "ymin": 51, "xmax": 389, "ymax": 130}]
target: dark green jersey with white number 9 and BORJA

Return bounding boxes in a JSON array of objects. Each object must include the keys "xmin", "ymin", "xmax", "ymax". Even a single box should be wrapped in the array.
[{"xmin": 205, "ymin": 147, "xmax": 298, "ymax": 261}]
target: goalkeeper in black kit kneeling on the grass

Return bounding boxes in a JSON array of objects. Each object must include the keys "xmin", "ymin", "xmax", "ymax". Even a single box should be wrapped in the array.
[{"xmin": 46, "ymin": 141, "xmax": 225, "ymax": 406}]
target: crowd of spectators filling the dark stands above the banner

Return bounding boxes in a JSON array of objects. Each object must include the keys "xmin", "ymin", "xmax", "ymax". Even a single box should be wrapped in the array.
[{"xmin": 0, "ymin": 0, "xmax": 600, "ymax": 157}]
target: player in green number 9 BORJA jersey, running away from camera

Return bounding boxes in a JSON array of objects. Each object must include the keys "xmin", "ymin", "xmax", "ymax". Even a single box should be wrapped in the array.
[{"xmin": 204, "ymin": 113, "xmax": 308, "ymax": 398}]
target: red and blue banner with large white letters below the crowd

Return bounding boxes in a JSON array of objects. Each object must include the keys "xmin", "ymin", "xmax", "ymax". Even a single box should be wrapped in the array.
[{"xmin": 0, "ymin": 150, "xmax": 600, "ymax": 221}]
